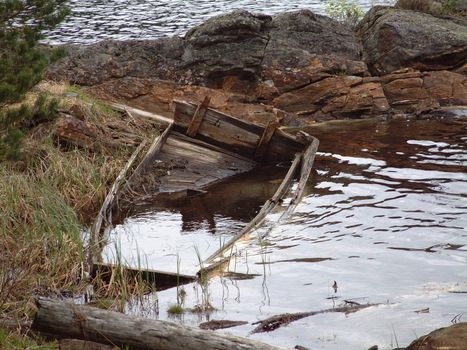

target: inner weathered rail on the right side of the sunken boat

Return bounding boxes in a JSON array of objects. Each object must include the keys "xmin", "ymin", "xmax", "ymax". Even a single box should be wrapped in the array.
[{"xmin": 201, "ymin": 153, "xmax": 302, "ymax": 266}]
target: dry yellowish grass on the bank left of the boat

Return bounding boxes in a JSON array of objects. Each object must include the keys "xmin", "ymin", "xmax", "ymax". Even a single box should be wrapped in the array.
[{"xmin": 0, "ymin": 82, "xmax": 161, "ymax": 326}]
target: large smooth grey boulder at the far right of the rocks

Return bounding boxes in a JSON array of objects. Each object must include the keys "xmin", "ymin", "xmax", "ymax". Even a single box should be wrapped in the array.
[{"xmin": 357, "ymin": 6, "xmax": 467, "ymax": 75}]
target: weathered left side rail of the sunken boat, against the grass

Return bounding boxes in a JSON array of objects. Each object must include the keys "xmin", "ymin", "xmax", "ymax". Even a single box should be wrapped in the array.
[{"xmin": 87, "ymin": 141, "xmax": 146, "ymax": 272}]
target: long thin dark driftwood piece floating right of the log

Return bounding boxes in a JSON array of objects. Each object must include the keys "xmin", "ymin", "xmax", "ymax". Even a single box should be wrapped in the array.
[{"xmin": 251, "ymin": 303, "xmax": 378, "ymax": 333}]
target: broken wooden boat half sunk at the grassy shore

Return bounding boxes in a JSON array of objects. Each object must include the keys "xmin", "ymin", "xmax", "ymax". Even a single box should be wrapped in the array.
[{"xmin": 88, "ymin": 97, "xmax": 319, "ymax": 288}]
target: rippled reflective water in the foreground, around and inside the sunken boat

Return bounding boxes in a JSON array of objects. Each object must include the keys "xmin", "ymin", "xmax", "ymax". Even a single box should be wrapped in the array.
[{"xmin": 106, "ymin": 113, "xmax": 467, "ymax": 350}]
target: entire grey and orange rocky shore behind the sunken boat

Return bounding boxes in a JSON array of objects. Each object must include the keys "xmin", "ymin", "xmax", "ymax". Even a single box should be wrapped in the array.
[{"xmin": 47, "ymin": 6, "xmax": 467, "ymax": 126}]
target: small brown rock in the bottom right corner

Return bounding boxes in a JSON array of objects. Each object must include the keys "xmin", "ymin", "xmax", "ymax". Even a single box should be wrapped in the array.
[{"xmin": 406, "ymin": 322, "xmax": 467, "ymax": 350}]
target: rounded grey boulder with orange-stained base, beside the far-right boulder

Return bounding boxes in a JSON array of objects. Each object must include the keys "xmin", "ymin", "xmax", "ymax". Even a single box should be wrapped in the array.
[{"xmin": 260, "ymin": 10, "xmax": 367, "ymax": 100}]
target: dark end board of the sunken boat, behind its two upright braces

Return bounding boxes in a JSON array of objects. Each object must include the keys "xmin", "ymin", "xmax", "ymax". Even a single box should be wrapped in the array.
[{"xmin": 174, "ymin": 101, "xmax": 304, "ymax": 161}]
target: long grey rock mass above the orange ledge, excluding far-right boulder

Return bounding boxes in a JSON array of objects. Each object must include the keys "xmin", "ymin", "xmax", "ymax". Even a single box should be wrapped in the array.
[{"xmin": 47, "ymin": 10, "xmax": 367, "ymax": 100}]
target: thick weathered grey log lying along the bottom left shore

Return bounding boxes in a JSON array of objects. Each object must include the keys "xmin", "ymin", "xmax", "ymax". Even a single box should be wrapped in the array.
[{"xmin": 32, "ymin": 299, "xmax": 278, "ymax": 350}]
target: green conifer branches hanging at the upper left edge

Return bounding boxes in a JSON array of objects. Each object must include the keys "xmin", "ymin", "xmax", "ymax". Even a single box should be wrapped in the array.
[{"xmin": 0, "ymin": 0, "xmax": 68, "ymax": 160}]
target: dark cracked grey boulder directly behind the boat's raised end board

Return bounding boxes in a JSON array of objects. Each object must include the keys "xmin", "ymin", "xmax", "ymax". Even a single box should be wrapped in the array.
[{"xmin": 180, "ymin": 10, "xmax": 271, "ymax": 87}]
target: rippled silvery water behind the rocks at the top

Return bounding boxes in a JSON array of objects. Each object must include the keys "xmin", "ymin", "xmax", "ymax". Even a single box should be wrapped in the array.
[{"xmin": 46, "ymin": 0, "xmax": 392, "ymax": 44}]
